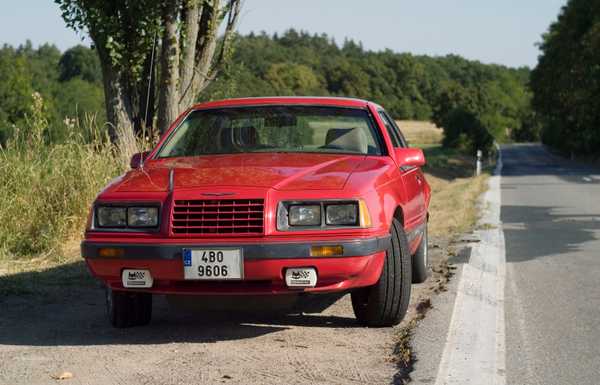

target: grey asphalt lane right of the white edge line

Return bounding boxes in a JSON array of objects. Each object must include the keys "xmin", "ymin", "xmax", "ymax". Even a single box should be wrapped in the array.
[{"xmin": 501, "ymin": 145, "xmax": 600, "ymax": 385}]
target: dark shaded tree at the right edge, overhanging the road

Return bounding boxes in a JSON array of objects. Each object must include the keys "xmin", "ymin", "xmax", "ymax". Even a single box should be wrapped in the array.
[{"xmin": 531, "ymin": 0, "xmax": 600, "ymax": 155}]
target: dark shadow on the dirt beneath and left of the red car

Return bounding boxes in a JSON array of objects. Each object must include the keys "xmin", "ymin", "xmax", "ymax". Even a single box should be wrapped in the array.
[{"xmin": 0, "ymin": 262, "xmax": 359, "ymax": 346}]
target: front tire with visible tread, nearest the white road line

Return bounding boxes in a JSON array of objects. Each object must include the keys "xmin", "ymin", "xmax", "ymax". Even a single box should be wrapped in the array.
[{"xmin": 351, "ymin": 219, "xmax": 412, "ymax": 327}]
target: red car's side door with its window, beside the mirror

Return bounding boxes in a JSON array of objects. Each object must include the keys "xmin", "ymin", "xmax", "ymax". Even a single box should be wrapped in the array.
[{"xmin": 378, "ymin": 110, "xmax": 426, "ymax": 227}]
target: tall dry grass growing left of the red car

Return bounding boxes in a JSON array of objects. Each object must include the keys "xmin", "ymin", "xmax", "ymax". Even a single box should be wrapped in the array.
[{"xmin": 0, "ymin": 94, "xmax": 124, "ymax": 261}]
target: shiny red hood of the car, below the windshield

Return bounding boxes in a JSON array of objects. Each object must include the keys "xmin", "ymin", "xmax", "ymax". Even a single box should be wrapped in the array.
[{"xmin": 111, "ymin": 153, "xmax": 365, "ymax": 192}]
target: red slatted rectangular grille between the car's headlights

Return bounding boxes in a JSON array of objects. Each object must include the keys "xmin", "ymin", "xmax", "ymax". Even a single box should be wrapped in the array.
[{"xmin": 171, "ymin": 199, "xmax": 265, "ymax": 236}]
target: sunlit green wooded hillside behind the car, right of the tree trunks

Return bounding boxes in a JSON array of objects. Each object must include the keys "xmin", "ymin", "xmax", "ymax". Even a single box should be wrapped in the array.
[{"xmin": 205, "ymin": 30, "xmax": 535, "ymax": 135}]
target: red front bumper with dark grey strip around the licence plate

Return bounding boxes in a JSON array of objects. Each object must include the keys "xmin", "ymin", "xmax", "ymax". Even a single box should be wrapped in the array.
[{"xmin": 81, "ymin": 236, "xmax": 390, "ymax": 295}]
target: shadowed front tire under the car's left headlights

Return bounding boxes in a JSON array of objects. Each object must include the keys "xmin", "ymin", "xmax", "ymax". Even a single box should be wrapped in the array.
[{"xmin": 106, "ymin": 287, "xmax": 152, "ymax": 328}]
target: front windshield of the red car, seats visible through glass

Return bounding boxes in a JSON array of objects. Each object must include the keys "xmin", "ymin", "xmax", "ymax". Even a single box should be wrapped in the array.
[{"xmin": 157, "ymin": 106, "xmax": 381, "ymax": 158}]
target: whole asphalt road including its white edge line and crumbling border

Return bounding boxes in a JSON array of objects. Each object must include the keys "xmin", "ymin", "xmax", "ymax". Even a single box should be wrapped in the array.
[{"xmin": 411, "ymin": 144, "xmax": 600, "ymax": 385}]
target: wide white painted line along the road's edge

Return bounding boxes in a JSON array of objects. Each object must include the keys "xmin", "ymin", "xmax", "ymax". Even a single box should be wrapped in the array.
[{"xmin": 435, "ymin": 146, "xmax": 506, "ymax": 385}]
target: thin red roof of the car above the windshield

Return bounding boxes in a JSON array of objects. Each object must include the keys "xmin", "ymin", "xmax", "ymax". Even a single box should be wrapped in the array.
[{"xmin": 192, "ymin": 96, "xmax": 370, "ymax": 109}]
